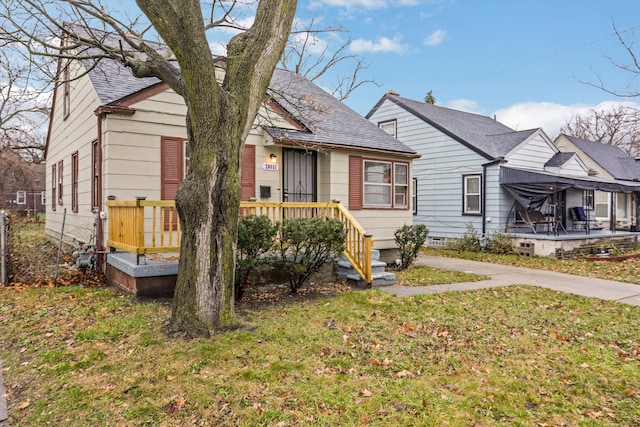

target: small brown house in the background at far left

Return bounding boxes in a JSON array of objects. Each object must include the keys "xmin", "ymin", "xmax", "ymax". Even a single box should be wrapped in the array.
[{"xmin": 0, "ymin": 153, "xmax": 46, "ymax": 215}]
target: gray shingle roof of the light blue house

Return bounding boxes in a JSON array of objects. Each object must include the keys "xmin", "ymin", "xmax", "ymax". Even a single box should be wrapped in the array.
[{"xmin": 366, "ymin": 94, "xmax": 538, "ymax": 160}]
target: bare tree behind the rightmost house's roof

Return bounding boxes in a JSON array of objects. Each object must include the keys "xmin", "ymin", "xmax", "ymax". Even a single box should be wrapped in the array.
[{"xmin": 560, "ymin": 105, "xmax": 640, "ymax": 156}]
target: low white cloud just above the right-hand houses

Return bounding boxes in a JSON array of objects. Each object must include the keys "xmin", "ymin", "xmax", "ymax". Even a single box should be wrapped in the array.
[{"xmin": 493, "ymin": 101, "xmax": 640, "ymax": 138}]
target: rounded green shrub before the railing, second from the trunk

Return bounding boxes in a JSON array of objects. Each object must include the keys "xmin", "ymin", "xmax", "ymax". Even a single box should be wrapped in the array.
[{"xmin": 278, "ymin": 218, "xmax": 346, "ymax": 293}]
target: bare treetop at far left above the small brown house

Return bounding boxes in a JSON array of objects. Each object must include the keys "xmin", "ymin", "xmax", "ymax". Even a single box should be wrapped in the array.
[{"xmin": 0, "ymin": 42, "xmax": 52, "ymax": 163}]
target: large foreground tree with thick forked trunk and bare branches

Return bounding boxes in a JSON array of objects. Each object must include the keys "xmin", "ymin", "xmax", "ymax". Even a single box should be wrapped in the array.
[{"xmin": 0, "ymin": 0, "xmax": 297, "ymax": 336}]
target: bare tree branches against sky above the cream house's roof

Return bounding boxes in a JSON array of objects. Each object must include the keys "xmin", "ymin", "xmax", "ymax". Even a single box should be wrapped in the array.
[{"xmin": 280, "ymin": 19, "xmax": 380, "ymax": 101}]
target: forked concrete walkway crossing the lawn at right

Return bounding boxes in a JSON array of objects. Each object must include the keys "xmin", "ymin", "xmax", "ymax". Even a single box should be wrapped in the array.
[{"xmin": 379, "ymin": 255, "xmax": 640, "ymax": 306}]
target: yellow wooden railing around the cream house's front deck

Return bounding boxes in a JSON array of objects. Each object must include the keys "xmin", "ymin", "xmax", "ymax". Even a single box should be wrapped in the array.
[{"xmin": 107, "ymin": 200, "xmax": 373, "ymax": 284}]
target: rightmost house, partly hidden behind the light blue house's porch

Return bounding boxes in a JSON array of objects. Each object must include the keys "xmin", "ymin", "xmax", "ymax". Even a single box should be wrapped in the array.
[{"xmin": 554, "ymin": 134, "xmax": 640, "ymax": 229}]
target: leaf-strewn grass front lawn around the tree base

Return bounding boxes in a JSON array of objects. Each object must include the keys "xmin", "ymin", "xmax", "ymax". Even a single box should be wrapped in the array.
[{"xmin": 0, "ymin": 286, "xmax": 640, "ymax": 427}]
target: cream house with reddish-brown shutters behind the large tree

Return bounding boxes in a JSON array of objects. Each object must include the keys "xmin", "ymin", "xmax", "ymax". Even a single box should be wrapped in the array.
[{"xmin": 46, "ymin": 29, "xmax": 418, "ymax": 260}]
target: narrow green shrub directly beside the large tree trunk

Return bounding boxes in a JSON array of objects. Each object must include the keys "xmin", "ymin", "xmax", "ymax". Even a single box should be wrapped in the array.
[{"xmin": 235, "ymin": 215, "xmax": 277, "ymax": 299}]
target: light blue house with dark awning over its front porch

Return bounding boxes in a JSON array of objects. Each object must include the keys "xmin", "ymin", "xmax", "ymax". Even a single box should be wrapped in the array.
[{"xmin": 366, "ymin": 92, "xmax": 640, "ymax": 256}]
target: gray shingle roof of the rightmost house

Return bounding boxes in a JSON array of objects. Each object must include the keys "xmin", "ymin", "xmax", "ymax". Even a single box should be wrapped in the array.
[{"xmin": 564, "ymin": 135, "xmax": 640, "ymax": 181}]
